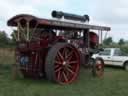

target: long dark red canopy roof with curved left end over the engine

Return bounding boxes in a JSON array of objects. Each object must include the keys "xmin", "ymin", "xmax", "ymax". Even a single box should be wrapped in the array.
[{"xmin": 7, "ymin": 14, "xmax": 111, "ymax": 31}]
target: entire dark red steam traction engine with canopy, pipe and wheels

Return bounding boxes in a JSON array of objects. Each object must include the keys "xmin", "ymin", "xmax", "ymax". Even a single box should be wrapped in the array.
[{"xmin": 7, "ymin": 11, "xmax": 110, "ymax": 84}]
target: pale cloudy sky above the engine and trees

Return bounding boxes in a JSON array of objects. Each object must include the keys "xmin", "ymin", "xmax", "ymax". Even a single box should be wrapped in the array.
[{"xmin": 0, "ymin": 0, "xmax": 128, "ymax": 41}]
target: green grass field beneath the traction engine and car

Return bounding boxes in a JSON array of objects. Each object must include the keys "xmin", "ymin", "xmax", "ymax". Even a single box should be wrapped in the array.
[{"xmin": 0, "ymin": 48, "xmax": 128, "ymax": 96}]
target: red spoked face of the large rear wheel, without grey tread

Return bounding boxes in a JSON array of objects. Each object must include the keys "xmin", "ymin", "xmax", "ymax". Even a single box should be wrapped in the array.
[{"xmin": 54, "ymin": 46, "xmax": 80, "ymax": 84}]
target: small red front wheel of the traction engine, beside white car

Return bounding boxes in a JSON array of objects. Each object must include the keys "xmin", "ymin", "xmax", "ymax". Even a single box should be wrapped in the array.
[{"xmin": 92, "ymin": 58, "xmax": 104, "ymax": 77}]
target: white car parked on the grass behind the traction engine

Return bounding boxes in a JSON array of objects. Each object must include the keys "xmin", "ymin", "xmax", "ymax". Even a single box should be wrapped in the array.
[{"xmin": 93, "ymin": 48, "xmax": 128, "ymax": 70}]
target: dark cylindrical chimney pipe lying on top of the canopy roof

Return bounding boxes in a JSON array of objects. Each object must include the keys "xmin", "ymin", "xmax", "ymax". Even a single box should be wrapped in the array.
[{"xmin": 51, "ymin": 11, "xmax": 89, "ymax": 22}]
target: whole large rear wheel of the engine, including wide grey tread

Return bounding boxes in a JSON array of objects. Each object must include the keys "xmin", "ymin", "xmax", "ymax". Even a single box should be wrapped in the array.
[{"xmin": 45, "ymin": 43, "xmax": 80, "ymax": 84}]
